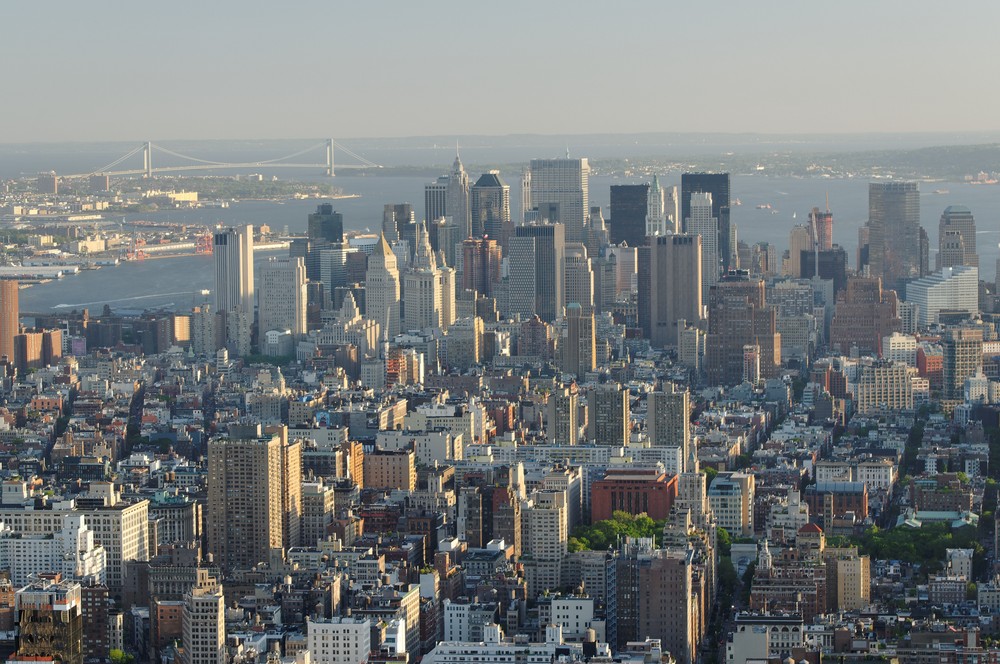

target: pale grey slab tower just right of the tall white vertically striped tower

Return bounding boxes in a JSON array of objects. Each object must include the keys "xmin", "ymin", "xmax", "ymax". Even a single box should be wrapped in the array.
[{"xmin": 258, "ymin": 258, "xmax": 308, "ymax": 337}]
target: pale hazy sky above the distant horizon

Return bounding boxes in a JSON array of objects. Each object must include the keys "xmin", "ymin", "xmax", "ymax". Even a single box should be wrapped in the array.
[{"xmin": 7, "ymin": 0, "xmax": 1000, "ymax": 143}]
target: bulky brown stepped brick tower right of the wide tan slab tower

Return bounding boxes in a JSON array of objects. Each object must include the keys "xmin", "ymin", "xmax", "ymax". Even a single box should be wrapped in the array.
[{"xmin": 705, "ymin": 272, "xmax": 781, "ymax": 385}]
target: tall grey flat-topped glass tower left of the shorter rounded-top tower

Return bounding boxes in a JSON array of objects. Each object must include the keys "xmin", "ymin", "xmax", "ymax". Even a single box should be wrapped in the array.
[{"xmin": 868, "ymin": 182, "xmax": 922, "ymax": 290}]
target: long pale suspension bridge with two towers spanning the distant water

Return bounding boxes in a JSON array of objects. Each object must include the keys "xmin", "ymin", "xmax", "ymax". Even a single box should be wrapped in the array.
[{"xmin": 61, "ymin": 138, "xmax": 382, "ymax": 178}]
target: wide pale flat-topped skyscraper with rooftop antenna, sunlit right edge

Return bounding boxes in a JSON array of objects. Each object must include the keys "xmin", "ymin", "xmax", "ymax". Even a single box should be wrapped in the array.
[{"xmin": 531, "ymin": 159, "xmax": 590, "ymax": 242}]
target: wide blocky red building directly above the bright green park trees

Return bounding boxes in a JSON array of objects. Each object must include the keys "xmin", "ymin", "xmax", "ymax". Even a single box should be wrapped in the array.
[{"xmin": 590, "ymin": 468, "xmax": 677, "ymax": 521}]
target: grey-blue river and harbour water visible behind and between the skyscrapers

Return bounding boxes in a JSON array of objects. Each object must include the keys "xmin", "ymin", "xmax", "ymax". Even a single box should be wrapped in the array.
[{"xmin": 13, "ymin": 173, "xmax": 1000, "ymax": 312}]
